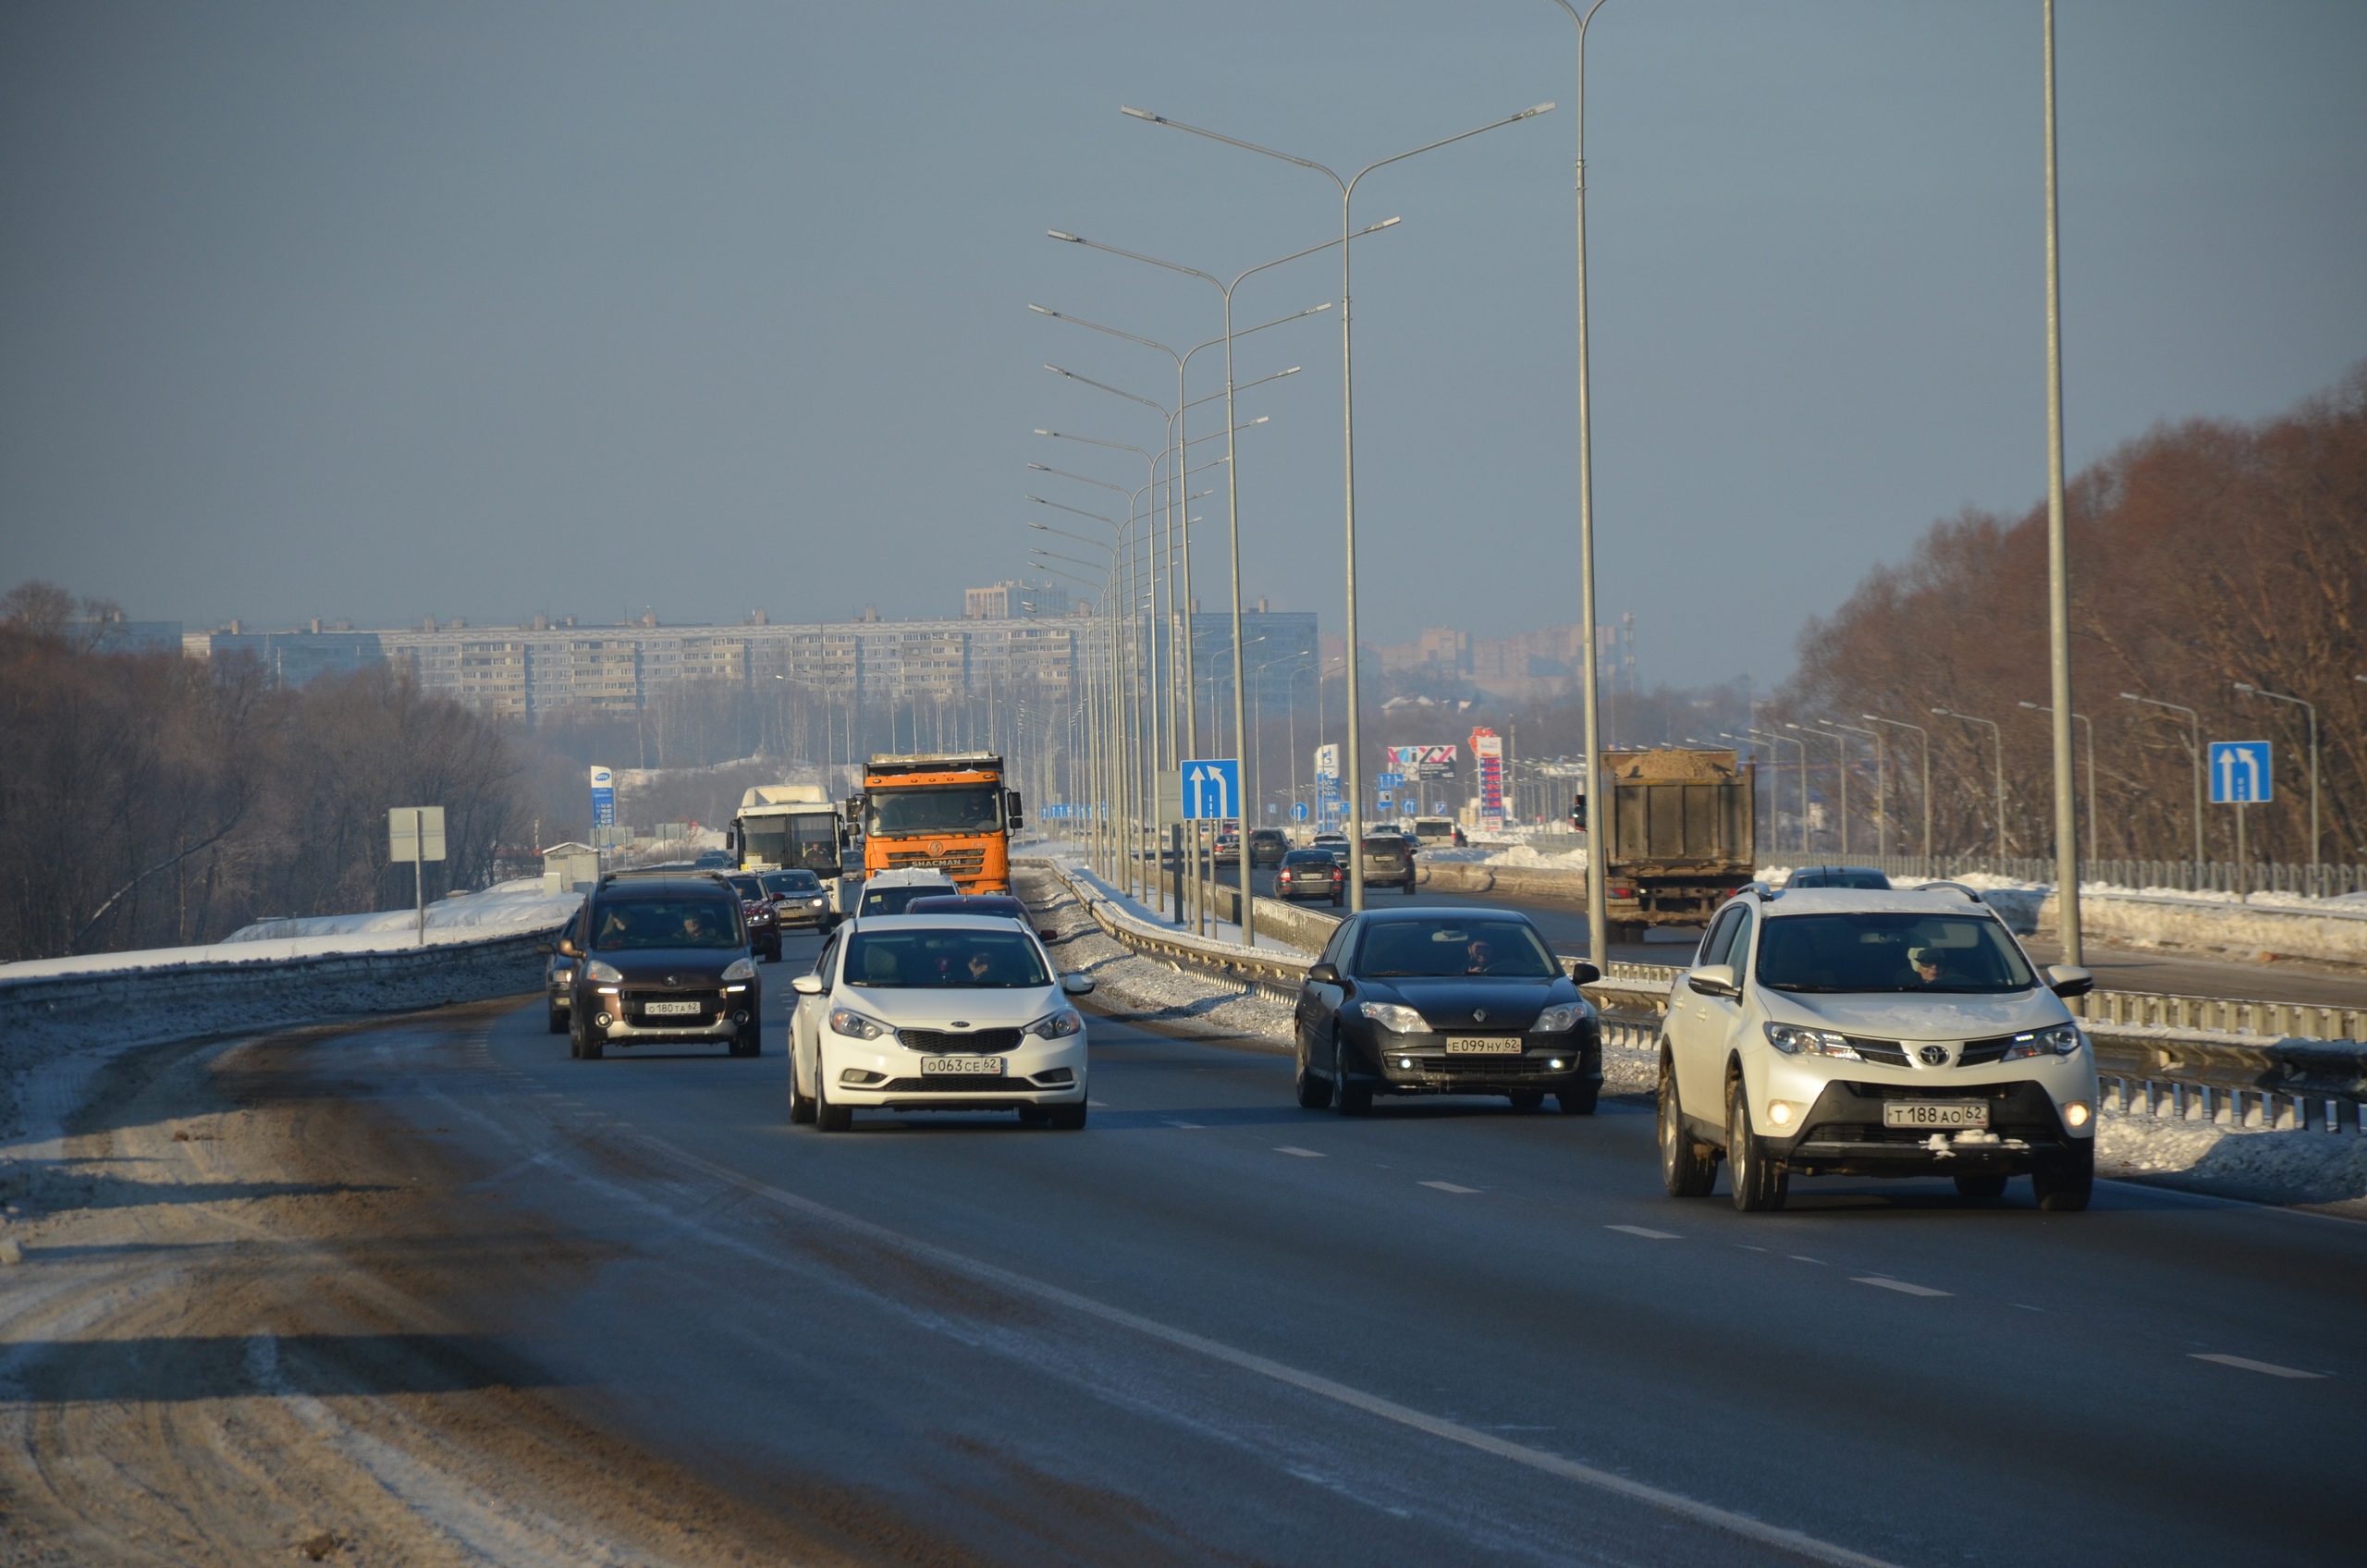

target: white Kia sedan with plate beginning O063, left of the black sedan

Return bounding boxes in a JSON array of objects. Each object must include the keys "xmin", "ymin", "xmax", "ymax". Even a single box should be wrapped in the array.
[{"xmin": 788, "ymin": 914, "xmax": 1094, "ymax": 1133}]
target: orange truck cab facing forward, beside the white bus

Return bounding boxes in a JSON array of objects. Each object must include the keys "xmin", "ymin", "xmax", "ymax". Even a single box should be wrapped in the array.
[{"xmin": 847, "ymin": 751, "xmax": 1020, "ymax": 893}]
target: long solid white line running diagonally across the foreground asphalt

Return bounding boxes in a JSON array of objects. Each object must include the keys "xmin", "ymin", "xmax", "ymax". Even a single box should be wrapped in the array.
[{"xmin": 648, "ymin": 1133, "xmax": 1896, "ymax": 1568}]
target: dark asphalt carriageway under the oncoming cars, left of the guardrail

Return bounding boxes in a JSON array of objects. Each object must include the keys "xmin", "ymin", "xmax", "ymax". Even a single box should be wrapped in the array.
[{"xmin": 189, "ymin": 938, "xmax": 2367, "ymax": 1565}]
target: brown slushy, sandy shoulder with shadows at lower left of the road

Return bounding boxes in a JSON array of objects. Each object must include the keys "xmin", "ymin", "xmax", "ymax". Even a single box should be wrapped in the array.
[{"xmin": 0, "ymin": 1002, "xmax": 965, "ymax": 1568}]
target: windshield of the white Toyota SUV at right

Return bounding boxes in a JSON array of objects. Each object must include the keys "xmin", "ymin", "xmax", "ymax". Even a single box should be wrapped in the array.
[{"xmin": 1759, "ymin": 910, "xmax": 2038, "ymax": 992}]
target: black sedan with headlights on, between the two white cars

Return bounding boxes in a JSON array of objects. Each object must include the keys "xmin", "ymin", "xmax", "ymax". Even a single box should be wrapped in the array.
[{"xmin": 1294, "ymin": 907, "xmax": 1602, "ymax": 1116}]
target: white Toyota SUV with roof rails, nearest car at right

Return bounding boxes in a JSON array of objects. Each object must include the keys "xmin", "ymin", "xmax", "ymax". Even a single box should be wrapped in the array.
[{"xmin": 1660, "ymin": 884, "xmax": 2097, "ymax": 1210}]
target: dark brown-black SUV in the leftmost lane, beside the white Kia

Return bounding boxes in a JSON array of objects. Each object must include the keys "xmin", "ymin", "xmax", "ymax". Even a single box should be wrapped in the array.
[{"xmin": 558, "ymin": 874, "xmax": 765, "ymax": 1061}]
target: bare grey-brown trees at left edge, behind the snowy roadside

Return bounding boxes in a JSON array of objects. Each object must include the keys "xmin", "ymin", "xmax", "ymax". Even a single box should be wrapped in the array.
[{"xmin": 0, "ymin": 582, "xmax": 530, "ymax": 960}]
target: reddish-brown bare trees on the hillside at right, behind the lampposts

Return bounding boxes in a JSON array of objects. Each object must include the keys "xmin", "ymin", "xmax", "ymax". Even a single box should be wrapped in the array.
[{"xmin": 1780, "ymin": 367, "xmax": 2367, "ymax": 863}]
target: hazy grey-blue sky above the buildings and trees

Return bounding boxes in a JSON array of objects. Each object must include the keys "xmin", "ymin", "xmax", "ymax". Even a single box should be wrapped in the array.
[{"xmin": 0, "ymin": 0, "xmax": 2367, "ymax": 682}]
